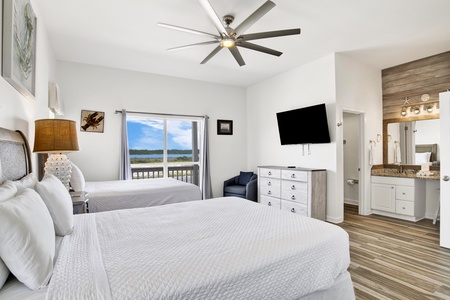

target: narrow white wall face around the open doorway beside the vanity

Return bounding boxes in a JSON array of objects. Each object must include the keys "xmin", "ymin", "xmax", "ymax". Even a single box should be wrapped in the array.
[{"xmin": 335, "ymin": 54, "xmax": 383, "ymax": 219}]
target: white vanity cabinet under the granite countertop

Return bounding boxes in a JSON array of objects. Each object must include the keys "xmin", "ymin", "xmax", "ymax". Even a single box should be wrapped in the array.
[{"xmin": 371, "ymin": 176, "xmax": 426, "ymax": 222}]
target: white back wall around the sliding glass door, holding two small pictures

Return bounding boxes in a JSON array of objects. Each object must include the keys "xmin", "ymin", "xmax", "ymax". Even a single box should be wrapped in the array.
[{"xmin": 58, "ymin": 62, "xmax": 247, "ymax": 196}]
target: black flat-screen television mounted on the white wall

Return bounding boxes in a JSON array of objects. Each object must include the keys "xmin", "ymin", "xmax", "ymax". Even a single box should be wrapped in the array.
[{"xmin": 277, "ymin": 103, "xmax": 330, "ymax": 145}]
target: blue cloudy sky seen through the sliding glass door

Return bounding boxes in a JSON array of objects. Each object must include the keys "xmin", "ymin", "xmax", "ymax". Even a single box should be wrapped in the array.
[{"xmin": 127, "ymin": 117, "xmax": 192, "ymax": 150}]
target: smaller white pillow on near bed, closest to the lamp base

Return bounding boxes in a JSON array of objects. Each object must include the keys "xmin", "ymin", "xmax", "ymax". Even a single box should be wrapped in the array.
[{"xmin": 34, "ymin": 174, "xmax": 73, "ymax": 236}]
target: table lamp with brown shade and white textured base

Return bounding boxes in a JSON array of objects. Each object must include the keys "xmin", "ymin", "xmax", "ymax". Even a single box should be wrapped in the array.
[{"xmin": 33, "ymin": 119, "xmax": 79, "ymax": 190}]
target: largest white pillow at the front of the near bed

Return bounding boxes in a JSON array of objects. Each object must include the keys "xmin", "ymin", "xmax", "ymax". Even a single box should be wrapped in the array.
[{"xmin": 0, "ymin": 189, "xmax": 55, "ymax": 290}]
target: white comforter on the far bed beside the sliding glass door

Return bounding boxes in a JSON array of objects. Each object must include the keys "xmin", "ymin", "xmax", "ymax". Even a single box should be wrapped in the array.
[{"xmin": 85, "ymin": 178, "xmax": 202, "ymax": 212}]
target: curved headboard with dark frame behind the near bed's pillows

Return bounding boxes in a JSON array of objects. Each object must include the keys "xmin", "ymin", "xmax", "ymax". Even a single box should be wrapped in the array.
[{"xmin": 0, "ymin": 127, "xmax": 31, "ymax": 183}]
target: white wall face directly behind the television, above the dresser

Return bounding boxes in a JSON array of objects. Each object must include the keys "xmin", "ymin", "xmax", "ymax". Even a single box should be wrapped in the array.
[{"xmin": 247, "ymin": 55, "xmax": 336, "ymax": 219}]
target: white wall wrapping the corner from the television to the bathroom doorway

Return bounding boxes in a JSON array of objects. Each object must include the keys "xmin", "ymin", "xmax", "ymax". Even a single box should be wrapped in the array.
[{"xmin": 247, "ymin": 54, "xmax": 382, "ymax": 223}]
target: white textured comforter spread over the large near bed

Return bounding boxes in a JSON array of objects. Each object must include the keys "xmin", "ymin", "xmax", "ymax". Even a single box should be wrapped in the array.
[{"xmin": 48, "ymin": 197, "xmax": 350, "ymax": 300}]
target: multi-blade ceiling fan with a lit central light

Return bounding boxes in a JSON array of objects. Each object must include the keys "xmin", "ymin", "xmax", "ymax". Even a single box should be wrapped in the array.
[{"xmin": 157, "ymin": 0, "xmax": 300, "ymax": 66}]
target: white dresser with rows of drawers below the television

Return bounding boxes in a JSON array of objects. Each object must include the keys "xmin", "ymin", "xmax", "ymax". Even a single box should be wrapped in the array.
[{"xmin": 258, "ymin": 166, "xmax": 327, "ymax": 220}]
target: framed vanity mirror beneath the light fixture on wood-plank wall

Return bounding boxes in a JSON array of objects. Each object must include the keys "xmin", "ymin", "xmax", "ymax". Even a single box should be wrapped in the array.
[{"xmin": 383, "ymin": 118, "xmax": 440, "ymax": 166}]
